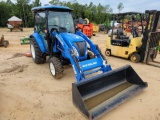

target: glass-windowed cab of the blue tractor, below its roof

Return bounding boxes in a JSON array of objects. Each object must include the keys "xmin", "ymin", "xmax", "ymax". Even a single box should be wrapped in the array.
[{"xmin": 32, "ymin": 7, "xmax": 75, "ymax": 34}]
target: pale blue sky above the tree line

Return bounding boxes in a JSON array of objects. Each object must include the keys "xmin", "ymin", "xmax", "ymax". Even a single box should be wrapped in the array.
[{"xmin": 0, "ymin": 0, "xmax": 160, "ymax": 13}]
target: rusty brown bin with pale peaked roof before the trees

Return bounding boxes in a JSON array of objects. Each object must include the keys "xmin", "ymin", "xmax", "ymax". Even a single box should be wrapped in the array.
[{"xmin": 7, "ymin": 16, "xmax": 23, "ymax": 32}]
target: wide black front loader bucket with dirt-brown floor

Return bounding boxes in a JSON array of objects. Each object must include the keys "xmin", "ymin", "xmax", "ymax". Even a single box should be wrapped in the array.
[{"xmin": 72, "ymin": 65, "xmax": 148, "ymax": 119}]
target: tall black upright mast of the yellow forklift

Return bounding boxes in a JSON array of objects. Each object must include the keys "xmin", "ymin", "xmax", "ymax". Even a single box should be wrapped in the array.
[{"xmin": 140, "ymin": 10, "xmax": 160, "ymax": 64}]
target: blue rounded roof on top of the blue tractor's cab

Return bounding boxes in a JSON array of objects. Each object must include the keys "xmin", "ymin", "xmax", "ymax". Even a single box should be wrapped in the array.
[{"xmin": 31, "ymin": 5, "xmax": 72, "ymax": 11}]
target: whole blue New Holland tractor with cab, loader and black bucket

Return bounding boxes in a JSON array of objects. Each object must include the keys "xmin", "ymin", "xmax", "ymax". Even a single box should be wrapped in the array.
[{"xmin": 30, "ymin": 5, "xmax": 147, "ymax": 119}]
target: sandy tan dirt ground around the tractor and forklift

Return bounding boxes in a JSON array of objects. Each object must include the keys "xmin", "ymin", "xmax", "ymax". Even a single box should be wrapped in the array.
[{"xmin": 0, "ymin": 28, "xmax": 160, "ymax": 120}]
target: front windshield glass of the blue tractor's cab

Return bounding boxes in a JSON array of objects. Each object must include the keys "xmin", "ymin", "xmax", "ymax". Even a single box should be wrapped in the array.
[{"xmin": 48, "ymin": 11, "xmax": 75, "ymax": 33}]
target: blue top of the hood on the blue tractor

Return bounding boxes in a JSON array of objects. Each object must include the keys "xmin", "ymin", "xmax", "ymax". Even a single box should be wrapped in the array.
[{"xmin": 60, "ymin": 33, "xmax": 84, "ymax": 43}]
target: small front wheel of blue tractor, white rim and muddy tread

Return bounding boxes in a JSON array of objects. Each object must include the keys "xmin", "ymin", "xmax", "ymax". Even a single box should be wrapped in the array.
[{"xmin": 49, "ymin": 57, "xmax": 64, "ymax": 79}]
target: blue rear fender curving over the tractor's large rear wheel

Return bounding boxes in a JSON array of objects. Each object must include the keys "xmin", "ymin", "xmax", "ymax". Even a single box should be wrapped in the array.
[{"xmin": 30, "ymin": 32, "xmax": 46, "ymax": 53}]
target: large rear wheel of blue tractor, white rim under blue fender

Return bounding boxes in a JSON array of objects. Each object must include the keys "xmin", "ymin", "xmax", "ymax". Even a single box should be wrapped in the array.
[{"xmin": 30, "ymin": 38, "xmax": 46, "ymax": 64}]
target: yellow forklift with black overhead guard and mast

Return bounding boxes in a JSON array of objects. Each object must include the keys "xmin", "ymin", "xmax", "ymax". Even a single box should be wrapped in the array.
[{"xmin": 105, "ymin": 10, "xmax": 160, "ymax": 64}]
